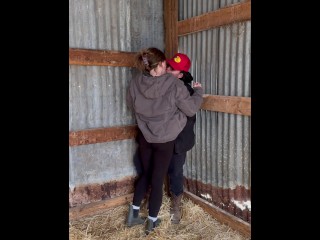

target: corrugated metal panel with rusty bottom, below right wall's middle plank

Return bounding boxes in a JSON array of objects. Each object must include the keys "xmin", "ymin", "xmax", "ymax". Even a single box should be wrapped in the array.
[{"xmin": 184, "ymin": 110, "xmax": 251, "ymax": 222}]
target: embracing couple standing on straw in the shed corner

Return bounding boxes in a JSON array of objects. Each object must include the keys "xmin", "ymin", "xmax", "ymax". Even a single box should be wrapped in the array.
[{"xmin": 126, "ymin": 48, "xmax": 203, "ymax": 234}]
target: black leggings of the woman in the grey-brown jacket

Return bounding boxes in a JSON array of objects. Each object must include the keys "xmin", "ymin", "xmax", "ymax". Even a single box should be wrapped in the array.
[{"xmin": 133, "ymin": 131, "xmax": 174, "ymax": 217}]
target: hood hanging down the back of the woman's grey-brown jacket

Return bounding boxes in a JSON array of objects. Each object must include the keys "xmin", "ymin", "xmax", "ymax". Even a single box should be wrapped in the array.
[{"xmin": 136, "ymin": 73, "xmax": 177, "ymax": 99}]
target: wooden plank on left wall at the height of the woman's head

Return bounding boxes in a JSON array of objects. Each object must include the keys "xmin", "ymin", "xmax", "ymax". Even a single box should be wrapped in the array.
[{"xmin": 69, "ymin": 48, "xmax": 136, "ymax": 67}]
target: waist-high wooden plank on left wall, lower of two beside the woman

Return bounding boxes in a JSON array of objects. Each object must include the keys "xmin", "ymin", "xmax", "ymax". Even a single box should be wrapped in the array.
[{"xmin": 69, "ymin": 125, "xmax": 138, "ymax": 146}]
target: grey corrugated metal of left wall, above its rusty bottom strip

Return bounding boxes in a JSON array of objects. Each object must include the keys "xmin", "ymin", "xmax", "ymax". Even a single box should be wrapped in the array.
[{"xmin": 69, "ymin": 0, "xmax": 164, "ymax": 190}]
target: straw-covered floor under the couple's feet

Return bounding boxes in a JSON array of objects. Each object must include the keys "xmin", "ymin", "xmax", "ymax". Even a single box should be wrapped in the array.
[{"xmin": 69, "ymin": 196, "xmax": 250, "ymax": 240}]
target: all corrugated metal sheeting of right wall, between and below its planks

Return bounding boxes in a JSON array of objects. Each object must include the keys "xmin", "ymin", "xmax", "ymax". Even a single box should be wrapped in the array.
[{"xmin": 178, "ymin": 0, "xmax": 251, "ymax": 222}]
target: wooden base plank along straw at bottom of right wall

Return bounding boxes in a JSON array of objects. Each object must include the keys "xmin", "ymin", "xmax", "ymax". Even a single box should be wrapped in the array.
[{"xmin": 183, "ymin": 191, "xmax": 251, "ymax": 237}]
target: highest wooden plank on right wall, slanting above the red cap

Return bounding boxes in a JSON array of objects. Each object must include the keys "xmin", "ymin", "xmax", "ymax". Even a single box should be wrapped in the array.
[{"xmin": 178, "ymin": 1, "xmax": 251, "ymax": 36}]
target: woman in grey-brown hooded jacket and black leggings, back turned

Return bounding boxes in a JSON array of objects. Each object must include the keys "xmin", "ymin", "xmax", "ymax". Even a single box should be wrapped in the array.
[{"xmin": 127, "ymin": 48, "xmax": 203, "ymax": 234}]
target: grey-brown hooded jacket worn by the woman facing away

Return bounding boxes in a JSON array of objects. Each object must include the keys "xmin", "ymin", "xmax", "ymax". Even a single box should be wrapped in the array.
[{"xmin": 127, "ymin": 73, "xmax": 203, "ymax": 143}]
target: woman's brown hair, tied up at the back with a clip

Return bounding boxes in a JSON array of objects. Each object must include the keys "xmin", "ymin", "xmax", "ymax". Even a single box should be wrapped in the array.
[{"xmin": 135, "ymin": 47, "xmax": 166, "ymax": 73}]
